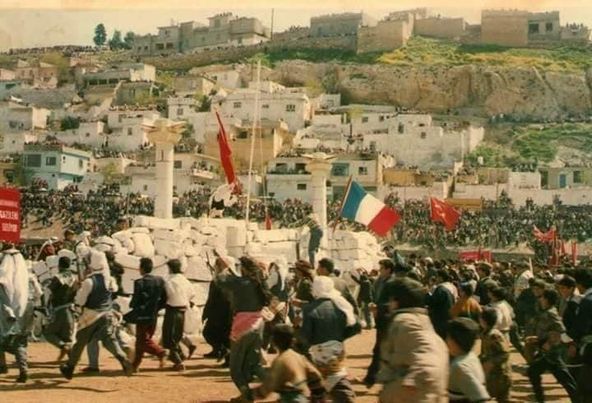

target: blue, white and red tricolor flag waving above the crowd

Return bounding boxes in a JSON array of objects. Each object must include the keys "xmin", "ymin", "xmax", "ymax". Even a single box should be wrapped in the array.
[{"xmin": 341, "ymin": 181, "xmax": 401, "ymax": 236}]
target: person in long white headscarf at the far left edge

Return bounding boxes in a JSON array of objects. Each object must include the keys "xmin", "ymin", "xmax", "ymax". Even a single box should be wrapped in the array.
[{"xmin": 0, "ymin": 247, "xmax": 33, "ymax": 383}]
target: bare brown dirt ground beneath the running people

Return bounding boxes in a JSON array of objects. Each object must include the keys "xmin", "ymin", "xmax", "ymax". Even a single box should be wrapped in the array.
[{"xmin": 0, "ymin": 331, "xmax": 569, "ymax": 403}]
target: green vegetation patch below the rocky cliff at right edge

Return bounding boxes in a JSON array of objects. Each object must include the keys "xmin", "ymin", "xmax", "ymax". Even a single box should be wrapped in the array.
[{"xmin": 468, "ymin": 123, "xmax": 592, "ymax": 167}]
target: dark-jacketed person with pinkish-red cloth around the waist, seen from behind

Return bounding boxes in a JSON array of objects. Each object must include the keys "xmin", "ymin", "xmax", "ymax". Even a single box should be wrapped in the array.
[{"xmin": 215, "ymin": 256, "xmax": 271, "ymax": 402}]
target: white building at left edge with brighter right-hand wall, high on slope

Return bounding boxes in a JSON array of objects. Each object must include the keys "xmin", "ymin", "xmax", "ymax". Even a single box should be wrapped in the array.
[{"xmin": 0, "ymin": 102, "xmax": 50, "ymax": 133}]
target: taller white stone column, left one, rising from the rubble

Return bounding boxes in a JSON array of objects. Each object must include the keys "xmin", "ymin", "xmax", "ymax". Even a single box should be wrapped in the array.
[{"xmin": 144, "ymin": 119, "xmax": 185, "ymax": 218}]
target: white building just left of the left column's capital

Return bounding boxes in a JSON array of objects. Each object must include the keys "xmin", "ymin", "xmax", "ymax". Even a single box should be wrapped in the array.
[{"xmin": 105, "ymin": 109, "xmax": 160, "ymax": 151}]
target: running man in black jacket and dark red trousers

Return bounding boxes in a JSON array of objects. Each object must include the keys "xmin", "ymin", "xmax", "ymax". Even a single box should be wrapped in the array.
[{"xmin": 126, "ymin": 258, "xmax": 166, "ymax": 372}]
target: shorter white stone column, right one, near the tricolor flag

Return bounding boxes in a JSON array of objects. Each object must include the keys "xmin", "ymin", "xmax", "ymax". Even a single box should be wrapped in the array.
[{"xmin": 305, "ymin": 153, "xmax": 335, "ymax": 234}]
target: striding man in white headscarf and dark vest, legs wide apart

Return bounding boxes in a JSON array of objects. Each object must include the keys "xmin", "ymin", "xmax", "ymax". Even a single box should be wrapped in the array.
[{"xmin": 60, "ymin": 249, "xmax": 132, "ymax": 379}]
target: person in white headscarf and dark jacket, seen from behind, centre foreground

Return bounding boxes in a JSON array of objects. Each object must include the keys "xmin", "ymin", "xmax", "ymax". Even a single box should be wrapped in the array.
[{"xmin": 300, "ymin": 276, "xmax": 356, "ymax": 403}]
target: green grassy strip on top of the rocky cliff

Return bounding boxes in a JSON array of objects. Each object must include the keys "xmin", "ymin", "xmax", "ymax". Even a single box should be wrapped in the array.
[{"xmin": 378, "ymin": 37, "xmax": 592, "ymax": 71}]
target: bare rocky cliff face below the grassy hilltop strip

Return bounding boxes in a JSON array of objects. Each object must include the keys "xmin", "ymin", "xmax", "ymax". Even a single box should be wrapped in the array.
[{"xmin": 264, "ymin": 60, "xmax": 592, "ymax": 121}]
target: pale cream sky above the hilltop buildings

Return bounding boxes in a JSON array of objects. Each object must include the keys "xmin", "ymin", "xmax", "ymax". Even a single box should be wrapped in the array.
[{"xmin": 0, "ymin": 0, "xmax": 592, "ymax": 50}]
